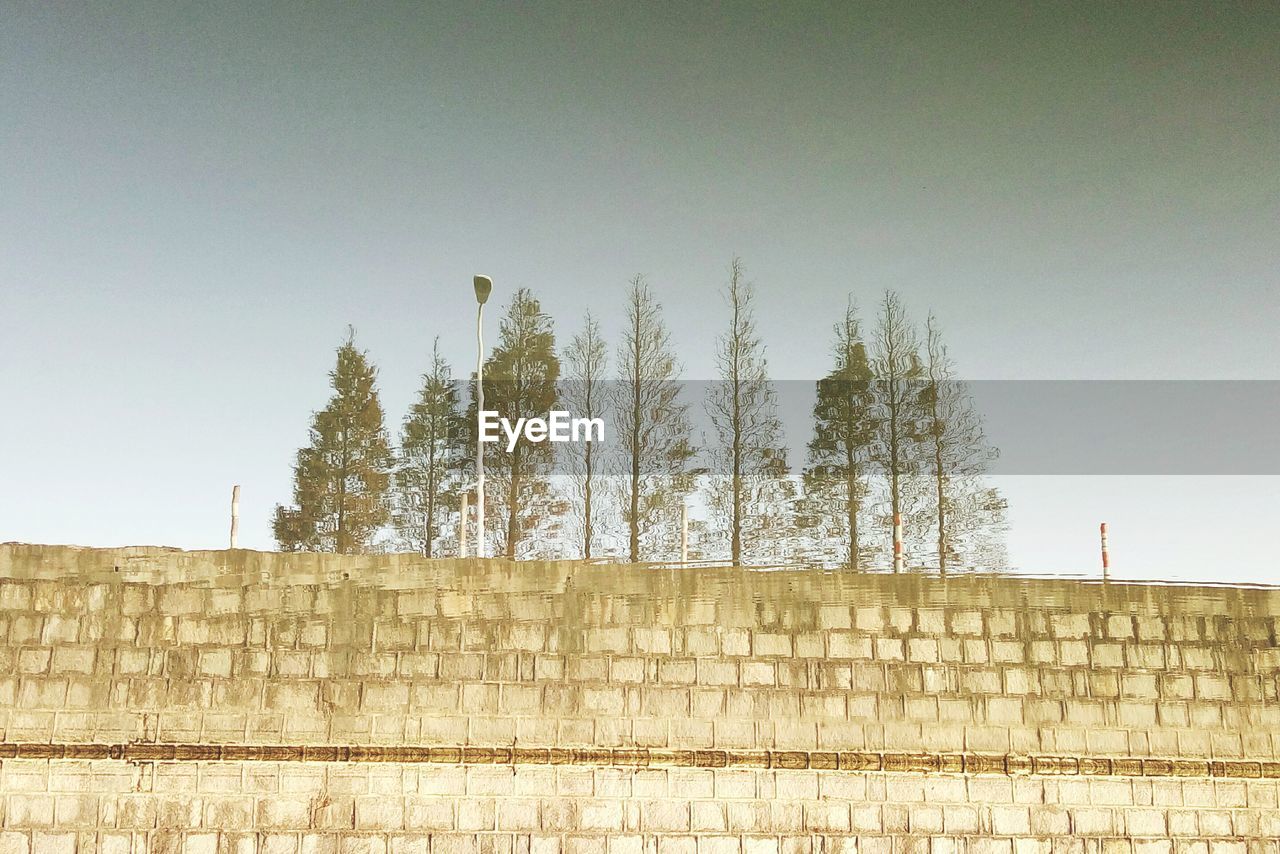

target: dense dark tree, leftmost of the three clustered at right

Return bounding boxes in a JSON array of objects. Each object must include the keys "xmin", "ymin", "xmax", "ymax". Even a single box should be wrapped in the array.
[{"xmin": 805, "ymin": 298, "xmax": 876, "ymax": 571}]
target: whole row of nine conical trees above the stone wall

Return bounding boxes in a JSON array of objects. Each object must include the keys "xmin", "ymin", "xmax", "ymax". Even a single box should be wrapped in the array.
[{"xmin": 273, "ymin": 259, "xmax": 1006, "ymax": 572}]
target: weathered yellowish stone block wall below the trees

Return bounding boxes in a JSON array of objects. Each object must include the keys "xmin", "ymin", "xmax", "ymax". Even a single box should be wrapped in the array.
[{"xmin": 0, "ymin": 545, "xmax": 1280, "ymax": 854}]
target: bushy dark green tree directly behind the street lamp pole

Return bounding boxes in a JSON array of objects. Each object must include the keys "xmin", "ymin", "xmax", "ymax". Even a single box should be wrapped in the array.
[{"xmin": 468, "ymin": 288, "xmax": 559, "ymax": 560}]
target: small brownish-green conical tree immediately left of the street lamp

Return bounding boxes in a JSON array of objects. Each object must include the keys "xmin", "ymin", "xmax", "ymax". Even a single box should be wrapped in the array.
[{"xmin": 396, "ymin": 338, "xmax": 470, "ymax": 557}]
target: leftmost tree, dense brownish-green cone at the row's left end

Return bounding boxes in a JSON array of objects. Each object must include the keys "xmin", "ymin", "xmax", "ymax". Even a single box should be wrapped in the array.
[{"xmin": 271, "ymin": 329, "xmax": 392, "ymax": 554}]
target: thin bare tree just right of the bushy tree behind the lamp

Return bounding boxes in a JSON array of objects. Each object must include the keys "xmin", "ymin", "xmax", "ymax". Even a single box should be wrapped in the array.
[{"xmin": 561, "ymin": 312, "xmax": 609, "ymax": 560}]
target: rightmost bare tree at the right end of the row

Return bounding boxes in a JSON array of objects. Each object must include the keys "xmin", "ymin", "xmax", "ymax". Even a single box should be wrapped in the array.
[{"xmin": 919, "ymin": 312, "xmax": 1005, "ymax": 574}]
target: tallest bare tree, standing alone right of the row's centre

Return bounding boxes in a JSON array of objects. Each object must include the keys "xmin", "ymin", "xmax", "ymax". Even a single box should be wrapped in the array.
[{"xmin": 707, "ymin": 257, "xmax": 787, "ymax": 565}]
